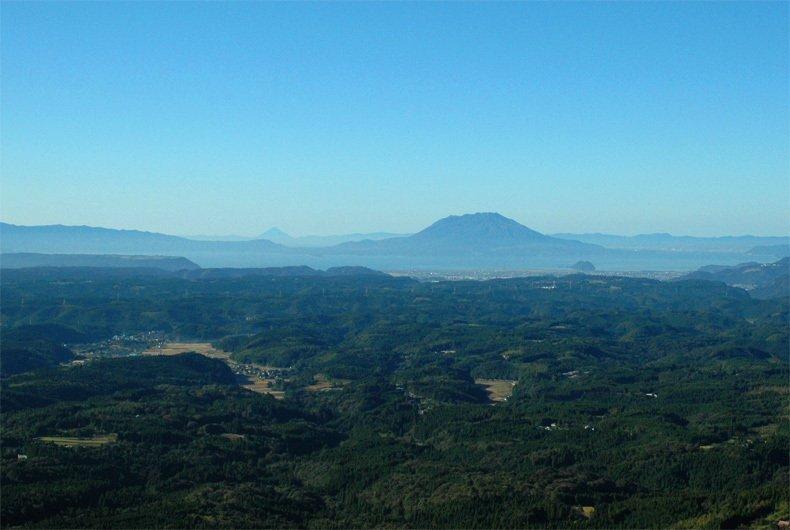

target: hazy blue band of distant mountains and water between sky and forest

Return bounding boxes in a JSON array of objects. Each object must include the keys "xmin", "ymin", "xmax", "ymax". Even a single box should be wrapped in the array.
[{"xmin": 0, "ymin": 213, "xmax": 790, "ymax": 270}]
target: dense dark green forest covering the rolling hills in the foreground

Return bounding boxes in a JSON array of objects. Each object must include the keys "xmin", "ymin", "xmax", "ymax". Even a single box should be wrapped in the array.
[{"xmin": 0, "ymin": 269, "xmax": 790, "ymax": 528}]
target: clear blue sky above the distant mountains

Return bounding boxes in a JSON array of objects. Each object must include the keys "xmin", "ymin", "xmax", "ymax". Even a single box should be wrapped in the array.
[{"xmin": 0, "ymin": 2, "xmax": 790, "ymax": 235}]
